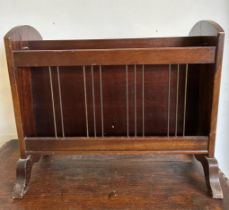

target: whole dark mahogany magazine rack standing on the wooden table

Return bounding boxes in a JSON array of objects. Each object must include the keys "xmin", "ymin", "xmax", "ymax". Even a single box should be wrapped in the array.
[{"xmin": 5, "ymin": 21, "xmax": 224, "ymax": 198}]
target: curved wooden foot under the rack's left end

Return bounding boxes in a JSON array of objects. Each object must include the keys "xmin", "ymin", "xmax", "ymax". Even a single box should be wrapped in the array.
[{"xmin": 12, "ymin": 156, "xmax": 40, "ymax": 198}]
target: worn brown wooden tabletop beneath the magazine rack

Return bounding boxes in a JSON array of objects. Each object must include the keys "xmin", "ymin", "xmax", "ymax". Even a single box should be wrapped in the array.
[{"xmin": 0, "ymin": 140, "xmax": 229, "ymax": 210}]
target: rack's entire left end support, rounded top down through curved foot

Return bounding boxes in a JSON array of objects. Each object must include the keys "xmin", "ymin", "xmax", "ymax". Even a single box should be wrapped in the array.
[{"xmin": 4, "ymin": 26, "xmax": 42, "ymax": 198}]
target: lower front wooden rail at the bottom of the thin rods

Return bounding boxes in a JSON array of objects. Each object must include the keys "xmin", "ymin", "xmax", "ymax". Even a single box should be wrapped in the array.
[{"xmin": 25, "ymin": 136, "xmax": 208, "ymax": 152}]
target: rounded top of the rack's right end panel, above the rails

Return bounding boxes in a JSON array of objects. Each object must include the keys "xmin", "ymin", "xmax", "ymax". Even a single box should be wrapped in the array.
[{"xmin": 189, "ymin": 20, "xmax": 224, "ymax": 36}]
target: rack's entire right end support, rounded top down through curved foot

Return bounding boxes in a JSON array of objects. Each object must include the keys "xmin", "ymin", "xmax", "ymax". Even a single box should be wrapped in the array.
[{"xmin": 190, "ymin": 21, "xmax": 224, "ymax": 199}]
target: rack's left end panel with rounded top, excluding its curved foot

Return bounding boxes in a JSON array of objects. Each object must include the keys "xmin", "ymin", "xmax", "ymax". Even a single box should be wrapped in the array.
[{"xmin": 4, "ymin": 25, "xmax": 42, "ymax": 158}]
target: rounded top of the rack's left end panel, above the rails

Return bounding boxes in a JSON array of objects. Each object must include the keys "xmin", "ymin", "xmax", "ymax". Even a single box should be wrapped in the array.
[{"xmin": 4, "ymin": 25, "xmax": 42, "ymax": 41}]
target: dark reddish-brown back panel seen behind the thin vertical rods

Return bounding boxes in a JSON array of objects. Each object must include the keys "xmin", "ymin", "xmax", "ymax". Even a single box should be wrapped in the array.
[{"xmin": 30, "ymin": 65, "xmax": 192, "ymax": 137}]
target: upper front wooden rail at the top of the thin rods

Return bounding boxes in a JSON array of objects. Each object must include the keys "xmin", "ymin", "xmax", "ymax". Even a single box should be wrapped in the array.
[{"xmin": 14, "ymin": 47, "xmax": 216, "ymax": 67}]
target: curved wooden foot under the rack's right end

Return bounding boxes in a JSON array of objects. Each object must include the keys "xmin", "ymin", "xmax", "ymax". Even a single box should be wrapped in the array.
[{"xmin": 195, "ymin": 155, "xmax": 223, "ymax": 199}]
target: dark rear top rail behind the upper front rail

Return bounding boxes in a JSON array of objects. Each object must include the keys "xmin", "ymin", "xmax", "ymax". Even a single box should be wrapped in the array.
[{"xmin": 25, "ymin": 36, "xmax": 217, "ymax": 50}]
